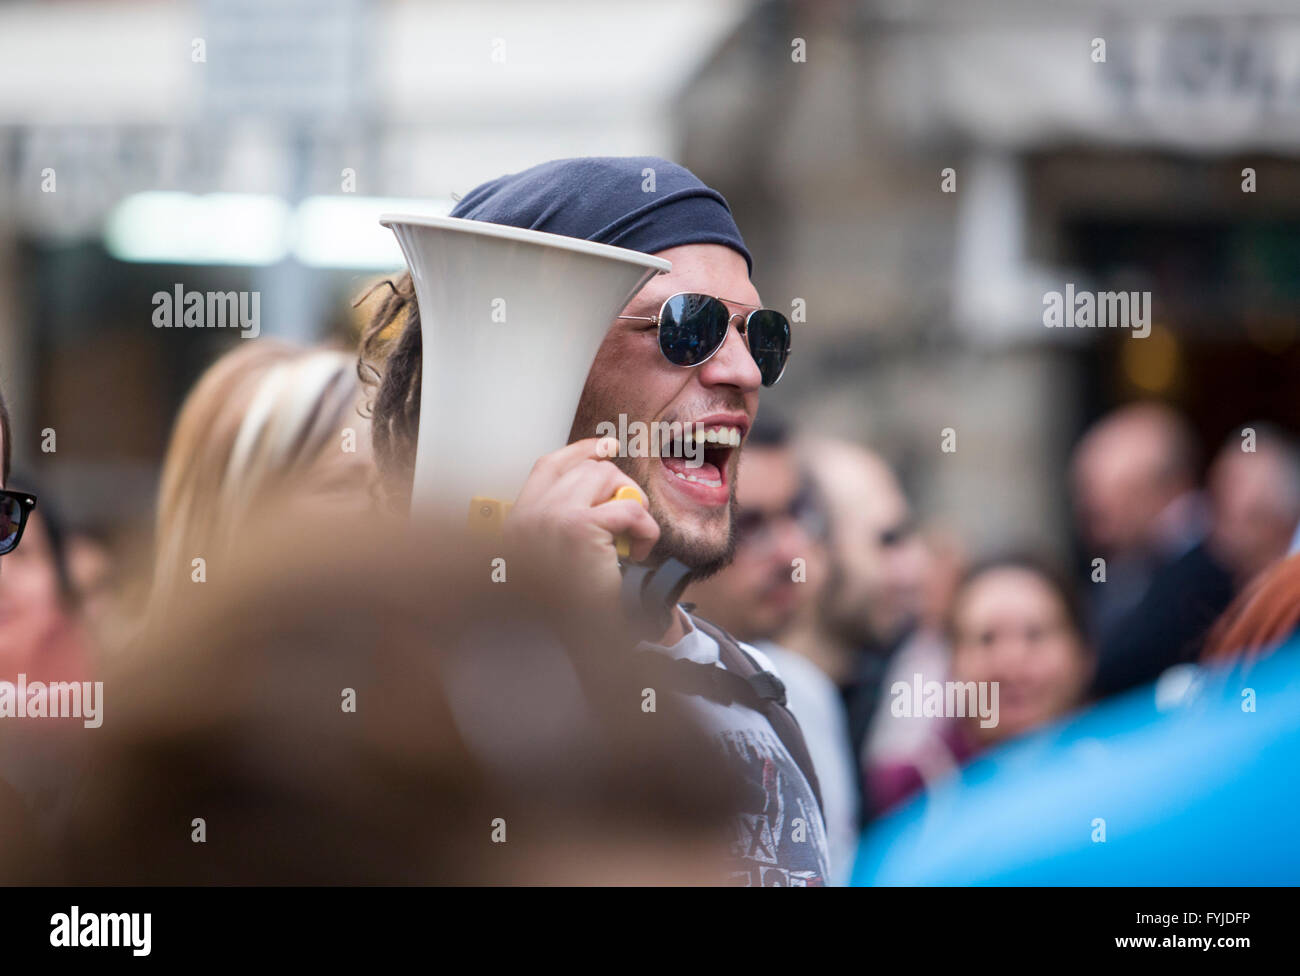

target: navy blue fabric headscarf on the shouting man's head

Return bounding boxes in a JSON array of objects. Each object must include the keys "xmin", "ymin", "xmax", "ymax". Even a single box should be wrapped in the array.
[{"xmin": 451, "ymin": 156, "xmax": 754, "ymax": 274}]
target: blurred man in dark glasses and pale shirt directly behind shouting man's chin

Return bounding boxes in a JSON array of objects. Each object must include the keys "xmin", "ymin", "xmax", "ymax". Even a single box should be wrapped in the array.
[{"xmin": 685, "ymin": 415, "xmax": 858, "ymax": 884}]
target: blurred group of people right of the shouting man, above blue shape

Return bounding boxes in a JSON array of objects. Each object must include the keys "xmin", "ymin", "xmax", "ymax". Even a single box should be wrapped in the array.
[{"xmin": 690, "ymin": 403, "xmax": 1300, "ymax": 869}]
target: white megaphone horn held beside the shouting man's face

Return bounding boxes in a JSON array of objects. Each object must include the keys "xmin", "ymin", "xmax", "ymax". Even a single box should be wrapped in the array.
[{"xmin": 380, "ymin": 214, "xmax": 672, "ymax": 525}]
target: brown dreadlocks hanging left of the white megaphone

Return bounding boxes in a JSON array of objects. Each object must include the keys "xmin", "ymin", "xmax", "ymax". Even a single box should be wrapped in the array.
[{"xmin": 354, "ymin": 272, "xmax": 423, "ymax": 509}]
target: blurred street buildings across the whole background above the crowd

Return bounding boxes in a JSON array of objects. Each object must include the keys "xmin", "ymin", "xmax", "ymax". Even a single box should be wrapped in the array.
[{"xmin": 0, "ymin": 0, "xmax": 1300, "ymax": 564}]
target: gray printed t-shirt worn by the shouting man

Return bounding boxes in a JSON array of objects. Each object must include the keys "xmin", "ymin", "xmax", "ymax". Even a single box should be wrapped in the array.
[{"xmin": 641, "ymin": 616, "xmax": 831, "ymax": 888}]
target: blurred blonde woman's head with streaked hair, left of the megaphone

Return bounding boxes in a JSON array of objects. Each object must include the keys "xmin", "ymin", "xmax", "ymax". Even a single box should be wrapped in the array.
[{"xmin": 150, "ymin": 339, "xmax": 373, "ymax": 612}]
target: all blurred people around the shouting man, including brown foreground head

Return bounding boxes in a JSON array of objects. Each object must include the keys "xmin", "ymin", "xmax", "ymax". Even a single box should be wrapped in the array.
[{"xmin": 0, "ymin": 326, "xmax": 1300, "ymax": 882}]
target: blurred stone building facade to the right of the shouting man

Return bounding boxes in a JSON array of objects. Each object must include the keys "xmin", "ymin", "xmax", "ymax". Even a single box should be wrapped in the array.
[{"xmin": 681, "ymin": 0, "xmax": 1300, "ymax": 561}]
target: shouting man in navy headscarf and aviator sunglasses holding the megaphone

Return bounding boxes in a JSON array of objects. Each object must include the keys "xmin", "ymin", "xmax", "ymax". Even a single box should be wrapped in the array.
[{"xmin": 361, "ymin": 156, "xmax": 829, "ymax": 886}]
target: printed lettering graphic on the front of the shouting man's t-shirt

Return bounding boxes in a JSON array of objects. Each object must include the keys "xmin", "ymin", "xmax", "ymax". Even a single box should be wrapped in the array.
[{"xmin": 719, "ymin": 726, "xmax": 828, "ymax": 888}]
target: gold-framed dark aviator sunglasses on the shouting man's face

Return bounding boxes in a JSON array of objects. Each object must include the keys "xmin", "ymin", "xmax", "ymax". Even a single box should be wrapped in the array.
[{"xmin": 619, "ymin": 291, "xmax": 790, "ymax": 386}]
